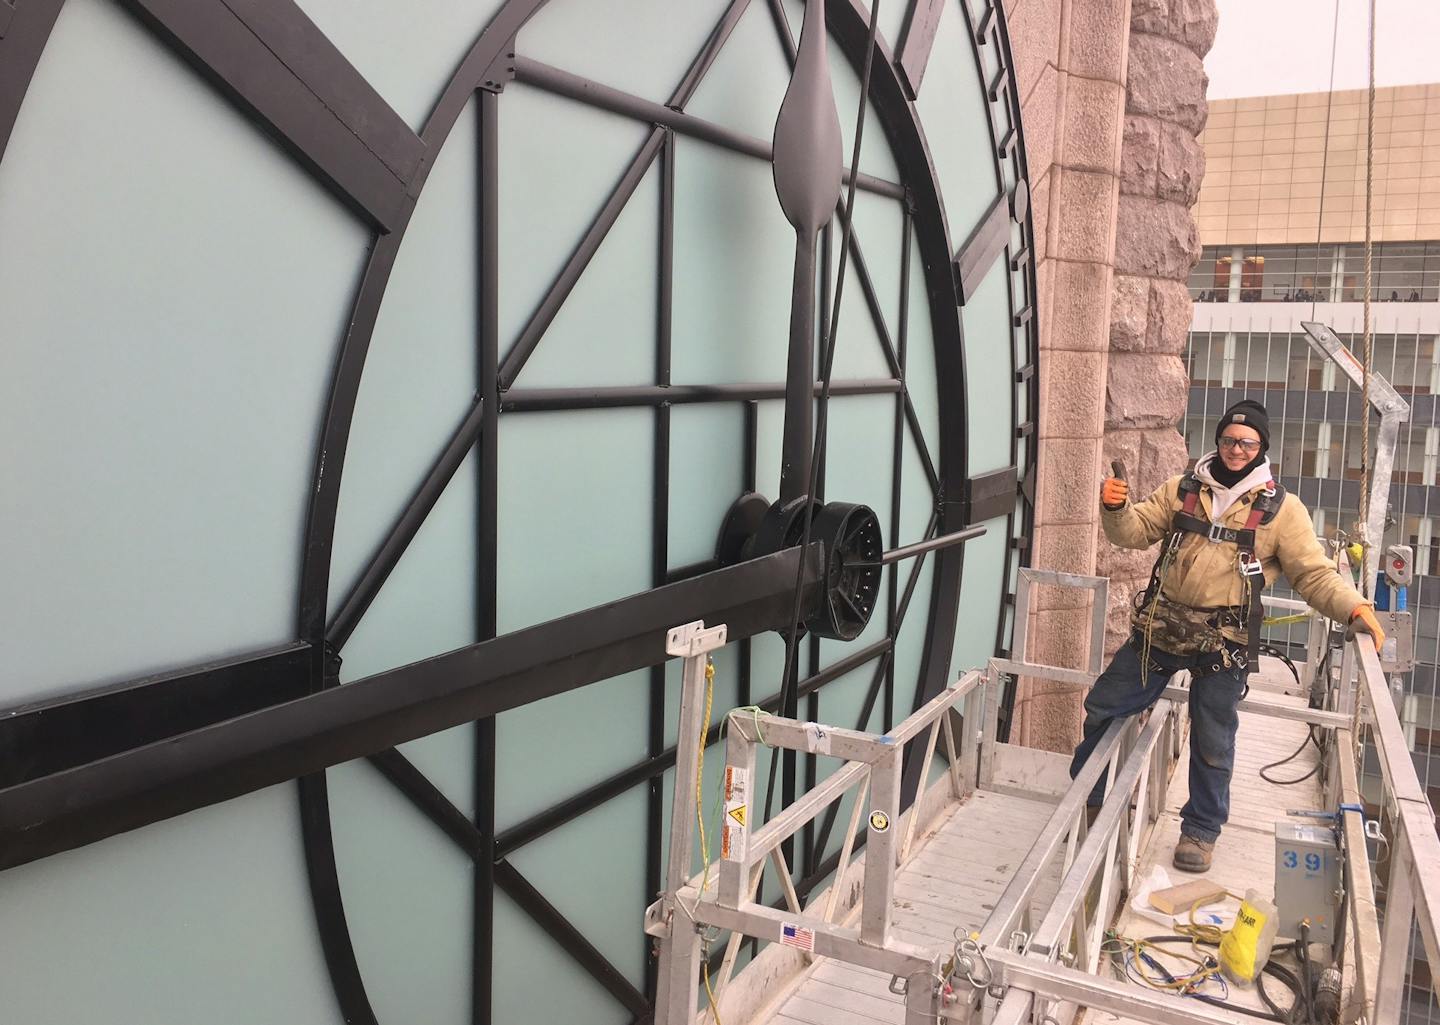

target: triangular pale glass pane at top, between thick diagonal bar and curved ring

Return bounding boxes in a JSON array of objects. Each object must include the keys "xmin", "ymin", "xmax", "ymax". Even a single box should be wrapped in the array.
[{"xmin": 297, "ymin": 0, "xmax": 504, "ymax": 131}]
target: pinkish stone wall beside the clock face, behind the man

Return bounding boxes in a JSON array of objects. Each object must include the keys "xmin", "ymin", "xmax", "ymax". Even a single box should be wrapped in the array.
[{"xmin": 1005, "ymin": 0, "xmax": 1215, "ymax": 750}]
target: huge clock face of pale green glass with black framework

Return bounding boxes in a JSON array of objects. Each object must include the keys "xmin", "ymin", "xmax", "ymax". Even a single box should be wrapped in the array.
[{"xmin": 0, "ymin": 0, "xmax": 1037, "ymax": 1024}]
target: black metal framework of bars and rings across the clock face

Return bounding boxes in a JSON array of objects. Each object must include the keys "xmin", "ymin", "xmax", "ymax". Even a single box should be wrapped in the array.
[{"xmin": 0, "ymin": 0, "xmax": 1038, "ymax": 1022}]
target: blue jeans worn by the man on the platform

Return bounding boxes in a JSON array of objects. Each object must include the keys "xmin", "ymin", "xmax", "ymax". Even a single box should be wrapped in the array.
[{"xmin": 1070, "ymin": 641, "xmax": 1246, "ymax": 844}]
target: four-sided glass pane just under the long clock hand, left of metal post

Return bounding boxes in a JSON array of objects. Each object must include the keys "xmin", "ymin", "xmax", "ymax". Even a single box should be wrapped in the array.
[{"xmin": 495, "ymin": 673, "xmax": 650, "ymax": 834}]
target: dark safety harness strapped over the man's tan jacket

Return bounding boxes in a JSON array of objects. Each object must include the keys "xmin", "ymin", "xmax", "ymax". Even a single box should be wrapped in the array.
[{"xmin": 1136, "ymin": 471, "xmax": 1284, "ymax": 678}]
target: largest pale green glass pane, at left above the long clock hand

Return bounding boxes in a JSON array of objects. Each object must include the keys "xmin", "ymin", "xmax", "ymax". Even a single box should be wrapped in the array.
[{"xmin": 0, "ymin": 0, "xmax": 369, "ymax": 705}]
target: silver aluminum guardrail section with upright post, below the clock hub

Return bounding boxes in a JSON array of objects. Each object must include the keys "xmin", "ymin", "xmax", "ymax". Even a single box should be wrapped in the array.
[{"xmin": 645, "ymin": 625, "xmax": 998, "ymax": 1025}]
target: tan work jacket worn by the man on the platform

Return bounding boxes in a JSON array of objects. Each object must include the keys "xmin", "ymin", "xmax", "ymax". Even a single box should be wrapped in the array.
[{"xmin": 1100, "ymin": 477, "xmax": 1368, "ymax": 642}]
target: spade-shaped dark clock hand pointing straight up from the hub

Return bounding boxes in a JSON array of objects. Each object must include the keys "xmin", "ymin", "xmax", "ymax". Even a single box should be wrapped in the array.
[{"xmin": 773, "ymin": 0, "xmax": 844, "ymax": 502}]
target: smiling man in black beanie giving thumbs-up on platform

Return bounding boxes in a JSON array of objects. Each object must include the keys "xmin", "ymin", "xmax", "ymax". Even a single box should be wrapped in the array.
[{"xmin": 1070, "ymin": 400, "xmax": 1385, "ymax": 872}]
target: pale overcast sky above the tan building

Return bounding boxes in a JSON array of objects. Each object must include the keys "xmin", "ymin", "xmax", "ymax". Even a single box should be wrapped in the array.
[{"xmin": 1205, "ymin": 0, "xmax": 1440, "ymax": 99}]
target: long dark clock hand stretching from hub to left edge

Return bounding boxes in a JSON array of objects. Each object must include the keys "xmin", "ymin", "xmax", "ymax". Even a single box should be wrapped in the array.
[{"xmin": 0, "ymin": 544, "xmax": 822, "ymax": 868}]
